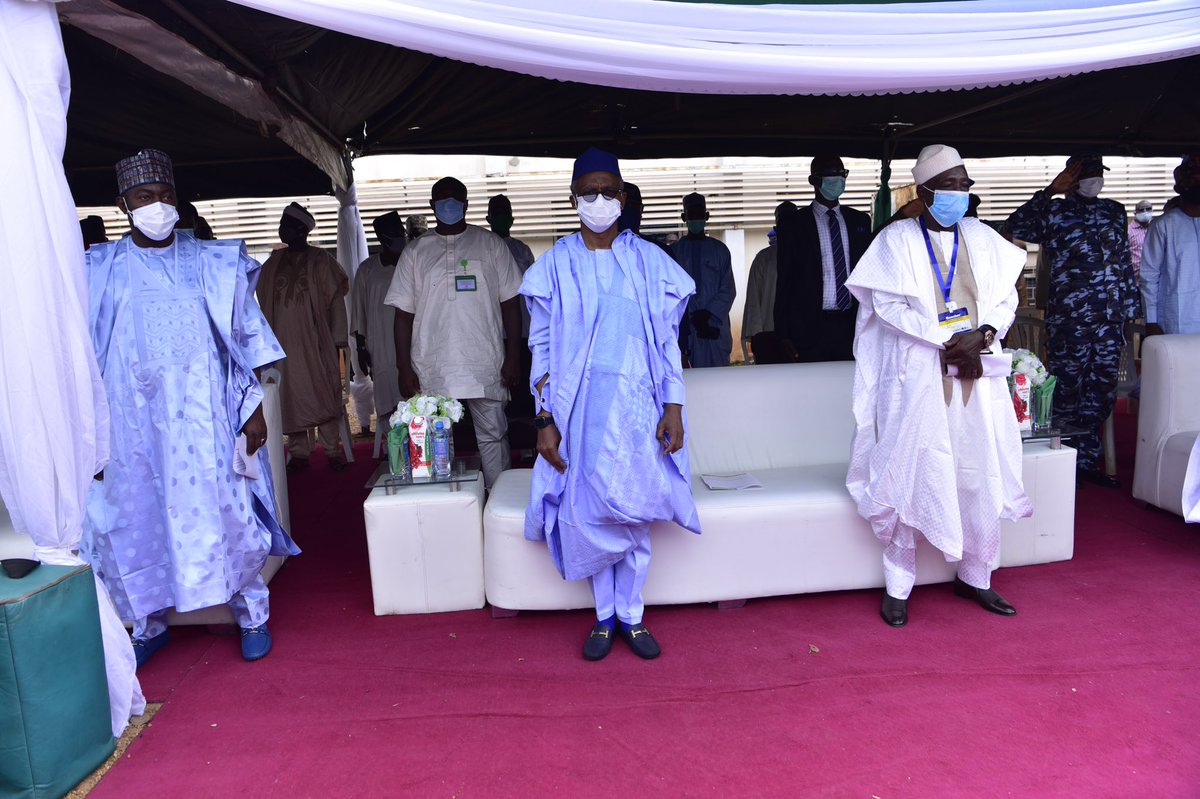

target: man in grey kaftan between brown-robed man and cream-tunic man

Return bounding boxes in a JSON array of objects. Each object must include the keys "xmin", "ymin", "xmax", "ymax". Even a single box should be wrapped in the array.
[{"xmin": 350, "ymin": 211, "xmax": 408, "ymax": 417}]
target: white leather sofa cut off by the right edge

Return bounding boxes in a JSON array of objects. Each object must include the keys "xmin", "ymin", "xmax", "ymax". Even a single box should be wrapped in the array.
[{"xmin": 1133, "ymin": 334, "xmax": 1200, "ymax": 516}]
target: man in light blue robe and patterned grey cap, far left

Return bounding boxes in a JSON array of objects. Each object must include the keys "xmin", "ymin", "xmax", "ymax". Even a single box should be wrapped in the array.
[{"xmin": 82, "ymin": 150, "xmax": 299, "ymax": 666}]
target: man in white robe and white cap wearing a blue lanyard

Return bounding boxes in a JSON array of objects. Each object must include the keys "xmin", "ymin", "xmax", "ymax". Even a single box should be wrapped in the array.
[{"xmin": 846, "ymin": 145, "xmax": 1033, "ymax": 626}]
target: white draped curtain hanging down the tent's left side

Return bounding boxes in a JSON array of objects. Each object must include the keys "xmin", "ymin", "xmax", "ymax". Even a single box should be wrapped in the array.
[{"xmin": 0, "ymin": 0, "xmax": 145, "ymax": 735}]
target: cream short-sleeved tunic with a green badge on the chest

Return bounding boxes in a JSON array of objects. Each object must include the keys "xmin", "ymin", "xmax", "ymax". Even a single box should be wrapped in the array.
[{"xmin": 384, "ymin": 224, "xmax": 521, "ymax": 401}]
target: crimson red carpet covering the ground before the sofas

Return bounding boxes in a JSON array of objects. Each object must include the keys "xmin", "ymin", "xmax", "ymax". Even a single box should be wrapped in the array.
[{"xmin": 92, "ymin": 417, "xmax": 1200, "ymax": 799}]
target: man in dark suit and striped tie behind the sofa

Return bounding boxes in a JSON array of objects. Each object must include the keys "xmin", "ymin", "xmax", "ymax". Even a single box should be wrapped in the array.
[{"xmin": 775, "ymin": 156, "xmax": 871, "ymax": 362}]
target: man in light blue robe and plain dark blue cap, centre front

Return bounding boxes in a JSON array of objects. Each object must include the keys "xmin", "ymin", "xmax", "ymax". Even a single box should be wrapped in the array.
[{"xmin": 521, "ymin": 148, "xmax": 700, "ymax": 660}]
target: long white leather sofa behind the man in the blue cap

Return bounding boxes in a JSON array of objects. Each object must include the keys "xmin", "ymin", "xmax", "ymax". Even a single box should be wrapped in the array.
[{"xmin": 484, "ymin": 362, "xmax": 1075, "ymax": 615}]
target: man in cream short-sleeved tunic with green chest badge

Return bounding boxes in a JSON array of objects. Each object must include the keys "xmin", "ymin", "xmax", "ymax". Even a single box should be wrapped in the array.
[{"xmin": 384, "ymin": 178, "xmax": 521, "ymax": 488}]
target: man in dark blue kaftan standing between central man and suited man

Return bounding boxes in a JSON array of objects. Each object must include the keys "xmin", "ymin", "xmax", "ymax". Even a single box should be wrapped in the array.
[{"xmin": 671, "ymin": 192, "xmax": 738, "ymax": 367}]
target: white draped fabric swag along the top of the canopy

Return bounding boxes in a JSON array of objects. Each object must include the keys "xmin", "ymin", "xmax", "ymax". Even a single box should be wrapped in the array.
[{"xmin": 233, "ymin": 0, "xmax": 1200, "ymax": 95}]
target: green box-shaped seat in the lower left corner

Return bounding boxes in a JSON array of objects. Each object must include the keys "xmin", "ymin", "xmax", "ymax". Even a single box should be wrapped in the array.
[{"xmin": 0, "ymin": 566, "xmax": 114, "ymax": 799}]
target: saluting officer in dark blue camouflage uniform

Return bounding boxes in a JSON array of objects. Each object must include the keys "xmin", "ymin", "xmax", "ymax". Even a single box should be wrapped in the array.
[{"xmin": 1006, "ymin": 154, "xmax": 1141, "ymax": 488}]
